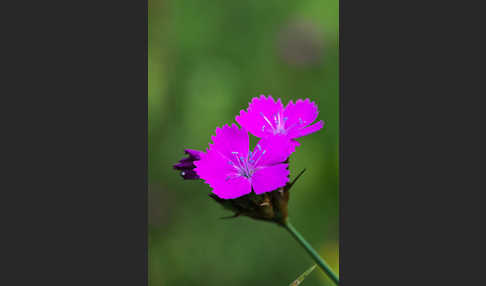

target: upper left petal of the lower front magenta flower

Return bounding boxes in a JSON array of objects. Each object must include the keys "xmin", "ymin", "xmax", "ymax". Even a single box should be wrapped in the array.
[{"xmin": 209, "ymin": 123, "xmax": 250, "ymax": 163}]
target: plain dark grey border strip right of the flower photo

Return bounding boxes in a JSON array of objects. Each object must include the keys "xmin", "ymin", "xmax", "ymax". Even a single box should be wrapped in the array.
[{"xmin": 339, "ymin": 0, "xmax": 474, "ymax": 285}]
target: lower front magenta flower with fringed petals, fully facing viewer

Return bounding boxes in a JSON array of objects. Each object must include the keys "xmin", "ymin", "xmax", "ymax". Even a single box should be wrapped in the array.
[{"xmin": 194, "ymin": 124, "xmax": 291, "ymax": 199}]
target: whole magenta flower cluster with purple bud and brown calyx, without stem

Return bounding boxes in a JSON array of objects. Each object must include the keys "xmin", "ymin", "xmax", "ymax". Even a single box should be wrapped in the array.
[{"xmin": 174, "ymin": 95, "xmax": 324, "ymax": 225}]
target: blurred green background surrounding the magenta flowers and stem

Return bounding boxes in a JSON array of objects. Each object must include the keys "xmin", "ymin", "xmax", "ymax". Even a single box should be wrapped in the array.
[{"xmin": 148, "ymin": 0, "xmax": 339, "ymax": 286}]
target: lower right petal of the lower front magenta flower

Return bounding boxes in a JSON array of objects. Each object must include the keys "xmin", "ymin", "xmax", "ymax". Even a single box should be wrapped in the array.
[{"xmin": 252, "ymin": 164, "xmax": 289, "ymax": 195}]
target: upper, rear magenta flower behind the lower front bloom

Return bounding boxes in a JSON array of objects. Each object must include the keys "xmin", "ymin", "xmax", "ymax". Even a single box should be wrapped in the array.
[{"xmin": 236, "ymin": 94, "xmax": 324, "ymax": 146}]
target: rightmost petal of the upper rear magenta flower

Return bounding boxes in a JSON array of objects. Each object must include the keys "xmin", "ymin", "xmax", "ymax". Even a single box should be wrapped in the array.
[{"xmin": 283, "ymin": 98, "xmax": 319, "ymax": 138}]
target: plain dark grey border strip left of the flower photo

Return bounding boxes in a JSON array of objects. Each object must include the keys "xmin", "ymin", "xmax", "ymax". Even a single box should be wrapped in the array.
[{"xmin": 0, "ymin": 0, "xmax": 148, "ymax": 286}]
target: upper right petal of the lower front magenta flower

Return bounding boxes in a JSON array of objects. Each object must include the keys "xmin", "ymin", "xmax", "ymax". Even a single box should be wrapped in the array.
[{"xmin": 253, "ymin": 135, "xmax": 299, "ymax": 166}]
